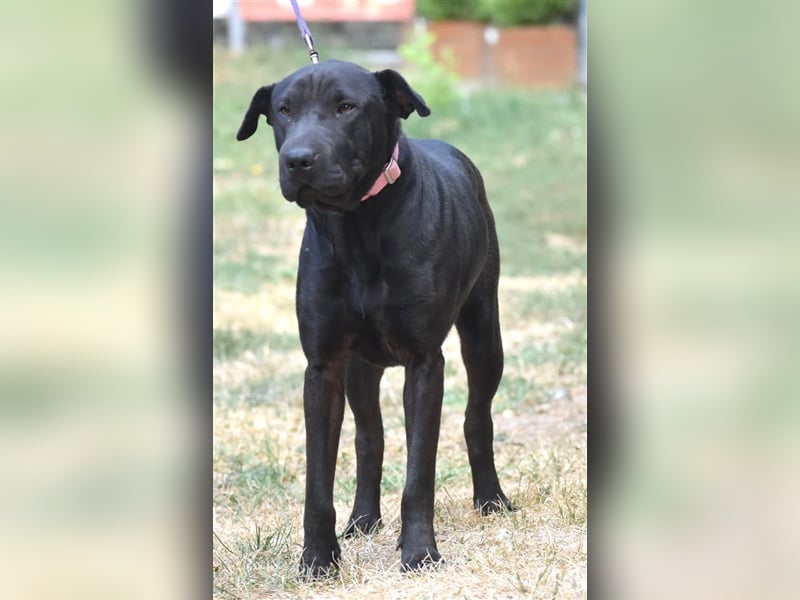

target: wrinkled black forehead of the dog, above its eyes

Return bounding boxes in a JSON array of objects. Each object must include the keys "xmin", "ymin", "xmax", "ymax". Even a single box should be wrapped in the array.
[{"xmin": 274, "ymin": 60, "xmax": 381, "ymax": 102}]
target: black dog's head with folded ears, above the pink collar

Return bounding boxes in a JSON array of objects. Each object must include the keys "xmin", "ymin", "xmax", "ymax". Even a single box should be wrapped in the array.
[{"xmin": 236, "ymin": 60, "xmax": 431, "ymax": 211}]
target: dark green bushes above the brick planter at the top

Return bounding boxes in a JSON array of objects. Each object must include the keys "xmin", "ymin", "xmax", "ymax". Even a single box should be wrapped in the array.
[{"xmin": 417, "ymin": 0, "xmax": 578, "ymax": 27}]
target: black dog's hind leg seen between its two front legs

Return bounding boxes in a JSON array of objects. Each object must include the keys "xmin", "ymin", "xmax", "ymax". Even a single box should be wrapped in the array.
[{"xmin": 344, "ymin": 354, "xmax": 383, "ymax": 537}]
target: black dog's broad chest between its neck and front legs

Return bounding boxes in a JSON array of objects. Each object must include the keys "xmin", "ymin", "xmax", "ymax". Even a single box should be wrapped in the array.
[{"xmin": 299, "ymin": 214, "xmax": 459, "ymax": 366}]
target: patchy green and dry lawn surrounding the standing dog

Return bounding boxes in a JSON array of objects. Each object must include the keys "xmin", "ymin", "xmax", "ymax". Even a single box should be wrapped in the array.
[{"xmin": 213, "ymin": 43, "xmax": 587, "ymax": 599}]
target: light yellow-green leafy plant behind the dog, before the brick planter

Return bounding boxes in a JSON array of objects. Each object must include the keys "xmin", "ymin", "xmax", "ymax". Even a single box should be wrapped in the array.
[{"xmin": 399, "ymin": 33, "xmax": 459, "ymax": 110}]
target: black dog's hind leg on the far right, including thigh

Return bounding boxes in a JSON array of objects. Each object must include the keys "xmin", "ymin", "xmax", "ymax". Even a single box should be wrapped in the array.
[{"xmin": 456, "ymin": 256, "xmax": 516, "ymax": 515}]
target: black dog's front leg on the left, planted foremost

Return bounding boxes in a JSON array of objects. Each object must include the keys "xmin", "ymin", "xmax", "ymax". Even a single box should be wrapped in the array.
[{"xmin": 301, "ymin": 364, "xmax": 344, "ymax": 577}]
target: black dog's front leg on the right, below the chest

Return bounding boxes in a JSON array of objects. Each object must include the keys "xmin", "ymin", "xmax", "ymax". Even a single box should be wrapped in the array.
[{"xmin": 397, "ymin": 350, "xmax": 444, "ymax": 570}]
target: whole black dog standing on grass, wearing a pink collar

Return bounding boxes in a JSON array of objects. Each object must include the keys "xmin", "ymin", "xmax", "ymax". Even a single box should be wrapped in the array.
[{"xmin": 236, "ymin": 60, "xmax": 515, "ymax": 576}]
